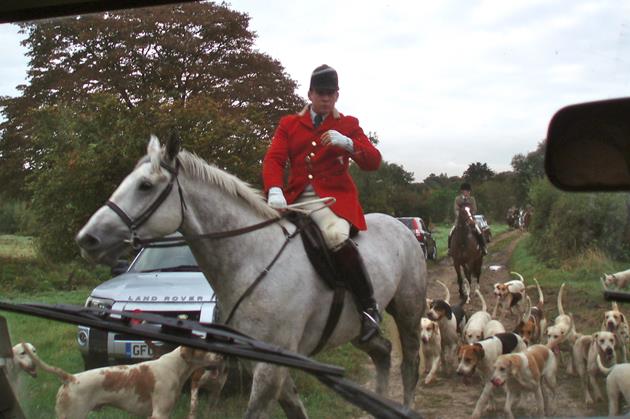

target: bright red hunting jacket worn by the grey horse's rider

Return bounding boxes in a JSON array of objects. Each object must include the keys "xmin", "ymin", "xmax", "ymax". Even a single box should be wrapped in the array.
[{"xmin": 263, "ymin": 106, "xmax": 381, "ymax": 230}]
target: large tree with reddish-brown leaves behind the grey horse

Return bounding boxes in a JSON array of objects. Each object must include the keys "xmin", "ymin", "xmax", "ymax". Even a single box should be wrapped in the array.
[{"xmin": 0, "ymin": 2, "xmax": 303, "ymax": 196}]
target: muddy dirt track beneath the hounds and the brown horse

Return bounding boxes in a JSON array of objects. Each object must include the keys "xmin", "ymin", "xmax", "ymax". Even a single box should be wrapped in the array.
[{"xmin": 366, "ymin": 231, "xmax": 624, "ymax": 419}]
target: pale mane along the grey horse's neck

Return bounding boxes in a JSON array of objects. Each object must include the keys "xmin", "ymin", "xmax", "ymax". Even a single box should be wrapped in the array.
[{"xmin": 177, "ymin": 150, "xmax": 279, "ymax": 218}]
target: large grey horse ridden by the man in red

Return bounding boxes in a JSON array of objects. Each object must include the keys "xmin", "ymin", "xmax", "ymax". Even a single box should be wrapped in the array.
[{"xmin": 76, "ymin": 136, "xmax": 427, "ymax": 418}]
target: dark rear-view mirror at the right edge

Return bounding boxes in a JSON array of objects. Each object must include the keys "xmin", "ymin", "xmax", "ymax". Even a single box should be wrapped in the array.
[{"xmin": 545, "ymin": 98, "xmax": 630, "ymax": 191}]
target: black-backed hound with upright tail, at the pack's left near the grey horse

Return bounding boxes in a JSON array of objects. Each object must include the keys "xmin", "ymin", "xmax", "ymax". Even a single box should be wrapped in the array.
[{"xmin": 427, "ymin": 281, "xmax": 466, "ymax": 365}]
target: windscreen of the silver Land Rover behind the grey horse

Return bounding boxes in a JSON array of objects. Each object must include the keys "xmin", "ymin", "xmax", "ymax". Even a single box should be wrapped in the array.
[{"xmin": 129, "ymin": 246, "xmax": 199, "ymax": 272}]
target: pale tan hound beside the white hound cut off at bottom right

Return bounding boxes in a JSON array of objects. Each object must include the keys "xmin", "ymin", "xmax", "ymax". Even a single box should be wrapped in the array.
[{"xmin": 573, "ymin": 331, "xmax": 617, "ymax": 405}]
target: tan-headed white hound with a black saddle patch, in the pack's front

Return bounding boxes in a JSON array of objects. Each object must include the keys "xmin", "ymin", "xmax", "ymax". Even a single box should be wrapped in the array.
[{"xmin": 457, "ymin": 333, "xmax": 527, "ymax": 418}]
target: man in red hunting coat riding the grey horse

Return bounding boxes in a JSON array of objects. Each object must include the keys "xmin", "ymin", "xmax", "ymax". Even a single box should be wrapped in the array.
[{"xmin": 263, "ymin": 65, "xmax": 381, "ymax": 342}]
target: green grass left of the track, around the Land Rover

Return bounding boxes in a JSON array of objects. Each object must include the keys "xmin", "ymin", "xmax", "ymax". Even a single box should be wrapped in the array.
[{"xmin": 0, "ymin": 236, "xmax": 368, "ymax": 419}]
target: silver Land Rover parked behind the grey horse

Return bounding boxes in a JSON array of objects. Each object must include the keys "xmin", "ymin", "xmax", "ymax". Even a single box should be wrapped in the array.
[{"xmin": 77, "ymin": 240, "xmax": 217, "ymax": 369}]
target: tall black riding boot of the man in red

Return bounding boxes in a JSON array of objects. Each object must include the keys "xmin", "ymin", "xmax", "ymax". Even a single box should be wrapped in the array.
[{"xmin": 332, "ymin": 240, "xmax": 381, "ymax": 343}]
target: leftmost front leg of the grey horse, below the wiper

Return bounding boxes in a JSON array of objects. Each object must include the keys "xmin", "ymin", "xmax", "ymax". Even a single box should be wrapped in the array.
[{"xmin": 244, "ymin": 362, "xmax": 288, "ymax": 419}]
